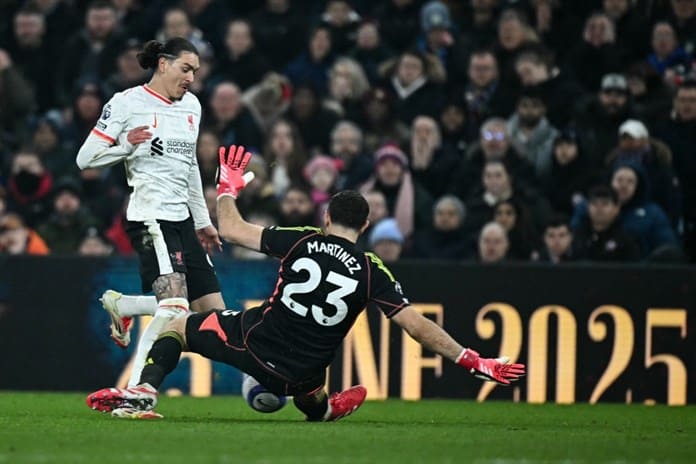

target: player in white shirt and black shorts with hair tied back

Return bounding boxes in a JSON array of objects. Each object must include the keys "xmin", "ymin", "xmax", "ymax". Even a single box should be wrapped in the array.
[{"xmin": 77, "ymin": 38, "xmax": 224, "ymax": 385}]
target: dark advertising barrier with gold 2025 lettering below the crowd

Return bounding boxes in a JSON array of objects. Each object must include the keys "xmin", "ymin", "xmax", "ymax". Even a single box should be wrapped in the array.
[{"xmin": 0, "ymin": 257, "xmax": 696, "ymax": 405}]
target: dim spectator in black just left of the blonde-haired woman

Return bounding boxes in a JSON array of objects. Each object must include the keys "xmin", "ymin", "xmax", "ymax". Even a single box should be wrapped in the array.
[{"xmin": 286, "ymin": 84, "xmax": 340, "ymax": 154}]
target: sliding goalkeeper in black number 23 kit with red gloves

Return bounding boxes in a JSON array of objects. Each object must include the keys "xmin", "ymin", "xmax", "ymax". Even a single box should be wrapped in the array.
[{"xmin": 87, "ymin": 145, "xmax": 525, "ymax": 421}]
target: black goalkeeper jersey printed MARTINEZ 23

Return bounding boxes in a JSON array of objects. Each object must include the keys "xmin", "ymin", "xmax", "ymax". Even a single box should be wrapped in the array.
[{"xmin": 243, "ymin": 227, "xmax": 409, "ymax": 379}]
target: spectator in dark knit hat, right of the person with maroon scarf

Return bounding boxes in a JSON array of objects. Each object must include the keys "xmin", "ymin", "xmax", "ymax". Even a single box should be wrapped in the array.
[{"xmin": 36, "ymin": 179, "xmax": 99, "ymax": 254}]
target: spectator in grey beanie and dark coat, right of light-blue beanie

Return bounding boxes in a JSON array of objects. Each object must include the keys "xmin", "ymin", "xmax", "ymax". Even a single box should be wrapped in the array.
[{"xmin": 409, "ymin": 195, "xmax": 474, "ymax": 261}]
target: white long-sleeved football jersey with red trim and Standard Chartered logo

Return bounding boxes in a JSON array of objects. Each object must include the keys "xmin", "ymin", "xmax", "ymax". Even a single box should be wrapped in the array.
[{"xmin": 77, "ymin": 85, "xmax": 211, "ymax": 229}]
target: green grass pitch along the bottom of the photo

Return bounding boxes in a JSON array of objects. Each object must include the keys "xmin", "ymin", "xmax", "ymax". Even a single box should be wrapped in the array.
[{"xmin": 0, "ymin": 392, "xmax": 696, "ymax": 464}]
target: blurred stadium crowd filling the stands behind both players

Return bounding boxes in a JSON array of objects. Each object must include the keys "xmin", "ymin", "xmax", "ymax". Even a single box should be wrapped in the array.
[{"xmin": 0, "ymin": 0, "xmax": 696, "ymax": 263}]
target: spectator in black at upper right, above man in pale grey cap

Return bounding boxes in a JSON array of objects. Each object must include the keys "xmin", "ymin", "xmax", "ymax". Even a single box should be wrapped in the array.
[{"xmin": 567, "ymin": 13, "xmax": 626, "ymax": 92}]
